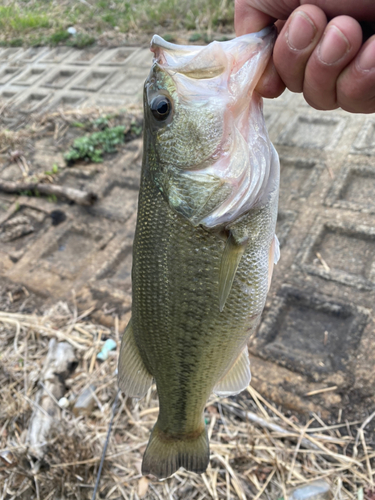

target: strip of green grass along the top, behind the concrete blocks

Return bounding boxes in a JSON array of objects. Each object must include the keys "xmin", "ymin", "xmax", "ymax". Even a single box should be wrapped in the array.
[{"xmin": 0, "ymin": 0, "xmax": 234, "ymax": 47}]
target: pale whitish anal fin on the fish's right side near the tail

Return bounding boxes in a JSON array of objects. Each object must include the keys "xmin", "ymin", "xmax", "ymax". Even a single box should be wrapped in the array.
[{"xmin": 214, "ymin": 346, "xmax": 251, "ymax": 397}]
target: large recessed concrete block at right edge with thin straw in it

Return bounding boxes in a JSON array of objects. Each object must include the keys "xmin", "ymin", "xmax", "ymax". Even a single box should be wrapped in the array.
[{"xmin": 297, "ymin": 217, "xmax": 375, "ymax": 290}]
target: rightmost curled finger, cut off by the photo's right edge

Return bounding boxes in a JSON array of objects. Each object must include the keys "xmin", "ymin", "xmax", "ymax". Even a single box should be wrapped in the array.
[{"xmin": 337, "ymin": 36, "xmax": 375, "ymax": 113}]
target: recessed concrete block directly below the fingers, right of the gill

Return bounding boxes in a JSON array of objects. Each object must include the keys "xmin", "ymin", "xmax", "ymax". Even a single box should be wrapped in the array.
[{"xmin": 277, "ymin": 115, "xmax": 346, "ymax": 150}]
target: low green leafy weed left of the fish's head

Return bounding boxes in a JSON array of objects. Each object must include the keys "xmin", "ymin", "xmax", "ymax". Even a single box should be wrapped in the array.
[{"xmin": 64, "ymin": 125, "xmax": 125, "ymax": 164}]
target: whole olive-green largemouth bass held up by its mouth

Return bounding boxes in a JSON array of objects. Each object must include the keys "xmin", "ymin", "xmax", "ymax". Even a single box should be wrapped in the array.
[{"xmin": 118, "ymin": 27, "xmax": 280, "ymax": 479}]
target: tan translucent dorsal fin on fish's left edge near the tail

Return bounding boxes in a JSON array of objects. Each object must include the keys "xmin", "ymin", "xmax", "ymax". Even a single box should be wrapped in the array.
[{"xmin": 118, "ymin": 320, "xmax": 153, "ymax": 398}]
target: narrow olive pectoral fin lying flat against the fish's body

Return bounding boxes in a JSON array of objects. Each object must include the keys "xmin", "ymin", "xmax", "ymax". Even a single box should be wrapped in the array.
[{"xmin": 219, "ymin": 233, "xmax": 247, "ymax": 312}]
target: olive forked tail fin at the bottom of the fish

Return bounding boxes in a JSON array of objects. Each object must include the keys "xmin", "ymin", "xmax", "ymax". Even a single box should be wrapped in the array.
[{"xmin": 142, "ymin": 423, "xmax": 210, "ymax": 479}]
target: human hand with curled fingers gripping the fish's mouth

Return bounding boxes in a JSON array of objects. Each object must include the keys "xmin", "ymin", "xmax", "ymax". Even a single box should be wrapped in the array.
[{"xmin": 235, "ymin": 0, "xmax": 375, "ymax": 113}]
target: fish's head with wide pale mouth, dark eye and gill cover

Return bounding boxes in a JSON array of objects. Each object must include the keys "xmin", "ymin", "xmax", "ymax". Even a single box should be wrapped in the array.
[{"xmin": 145, "ymin": 28, "xmax": 279, "ymax": 228}]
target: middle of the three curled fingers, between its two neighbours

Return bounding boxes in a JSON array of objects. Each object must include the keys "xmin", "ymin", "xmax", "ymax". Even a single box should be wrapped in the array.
[{"xmin": 303, "ymin": 16, "xmax": 362, "ymax": 109}]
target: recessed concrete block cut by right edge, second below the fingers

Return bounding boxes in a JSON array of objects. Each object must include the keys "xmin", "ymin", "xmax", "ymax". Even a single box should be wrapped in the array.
[{"xmin": 325, "ymin": 163, "xmax": 375, "ymax": 214}]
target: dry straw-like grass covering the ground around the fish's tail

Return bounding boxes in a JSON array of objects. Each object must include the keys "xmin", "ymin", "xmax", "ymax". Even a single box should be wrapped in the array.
[{"xmin": 0, "ymin": 303, "xmax": 375, "ymax": 500}]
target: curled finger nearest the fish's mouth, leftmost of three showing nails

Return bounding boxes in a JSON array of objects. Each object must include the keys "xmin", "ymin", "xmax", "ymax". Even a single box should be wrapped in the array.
[{"xmin": 273, "ymin": 5, "xmax": 327, "ymax": 92}]
